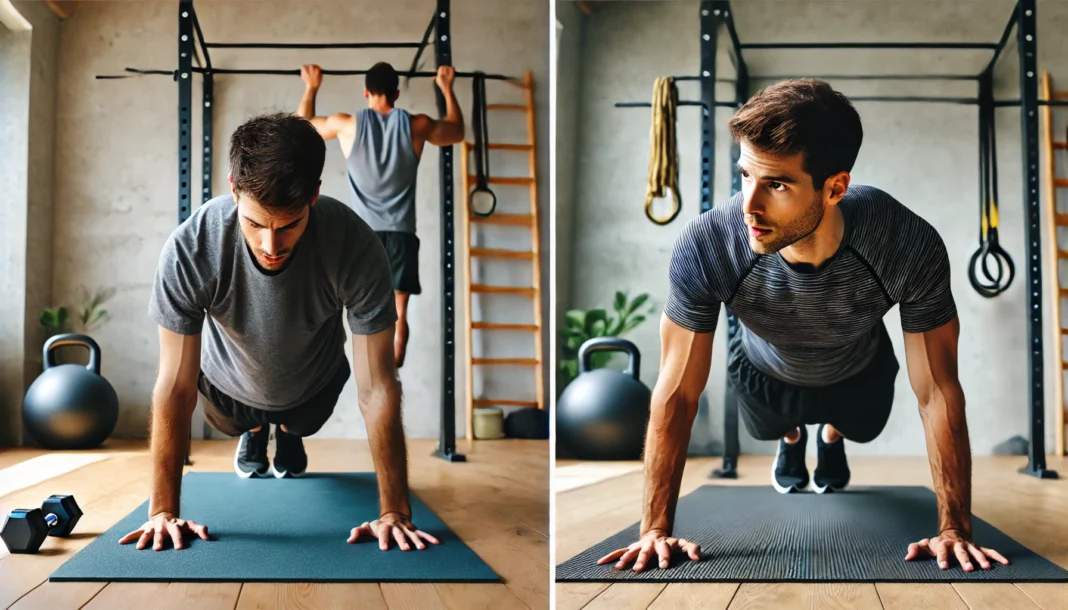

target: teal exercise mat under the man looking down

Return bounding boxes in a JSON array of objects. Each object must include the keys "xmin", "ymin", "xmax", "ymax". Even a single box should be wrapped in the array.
[{"xmin": 49, "ymin": 472, "xmax": 500, "ymax": 582}]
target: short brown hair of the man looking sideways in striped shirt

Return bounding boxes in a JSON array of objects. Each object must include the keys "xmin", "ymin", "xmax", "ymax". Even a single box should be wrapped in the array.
[{"xmin": 729, "ymin": 78, "xmax": 864, "ymax": 190}]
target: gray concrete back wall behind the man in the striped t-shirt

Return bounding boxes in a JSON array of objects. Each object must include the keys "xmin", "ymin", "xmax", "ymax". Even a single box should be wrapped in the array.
[{"xmin": 559, "ymin": 0, "xmax": 1068, "ymax": 454}]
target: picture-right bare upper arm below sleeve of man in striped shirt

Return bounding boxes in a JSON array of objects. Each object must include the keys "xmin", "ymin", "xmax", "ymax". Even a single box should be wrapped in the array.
[{"xmin": 905, "ymin": 315, "xmax": 961, "ymax": 407}]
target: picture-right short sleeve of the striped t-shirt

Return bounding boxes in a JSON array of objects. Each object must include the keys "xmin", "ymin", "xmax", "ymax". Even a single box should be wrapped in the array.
[{"xmin": 901, "ymin": 222, "xmax": 957, "ymax": 332}]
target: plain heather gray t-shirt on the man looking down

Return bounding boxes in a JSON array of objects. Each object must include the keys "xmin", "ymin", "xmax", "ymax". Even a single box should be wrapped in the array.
[{"xmin": 148, "ymin": 194, "xmax": 397, "ymax": 410}]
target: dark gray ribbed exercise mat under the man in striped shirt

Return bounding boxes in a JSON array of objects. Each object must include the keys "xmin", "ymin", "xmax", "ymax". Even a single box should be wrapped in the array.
[{"xmin": 556, "ymin": 485, "xmax": 1068, "ymax": 582}]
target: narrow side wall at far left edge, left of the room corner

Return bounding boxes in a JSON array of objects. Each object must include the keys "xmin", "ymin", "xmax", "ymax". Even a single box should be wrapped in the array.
[{"xmin": 0, "ymin": 2, "xmax": 59, "ymax": 447}]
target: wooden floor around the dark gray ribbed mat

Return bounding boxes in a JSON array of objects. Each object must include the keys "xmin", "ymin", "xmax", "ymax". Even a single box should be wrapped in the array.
[{"xmin": 553, "ymin": 456, "xmax": 1068, "ymax": 610}]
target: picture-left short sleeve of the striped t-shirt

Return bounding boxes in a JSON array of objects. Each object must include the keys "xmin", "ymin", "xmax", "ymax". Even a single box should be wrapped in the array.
[{"xmin": 664, "ymin": 223, "xmax": 720, "ymax": 332}]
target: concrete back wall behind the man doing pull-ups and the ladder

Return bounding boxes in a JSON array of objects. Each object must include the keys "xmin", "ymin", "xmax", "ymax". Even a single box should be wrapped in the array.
[{"xmin": 53, "ymin": 0, "xmax": 549, "ymax": 438}]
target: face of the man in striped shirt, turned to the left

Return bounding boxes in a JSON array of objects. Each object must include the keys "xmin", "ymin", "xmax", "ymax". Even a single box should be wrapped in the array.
[{"xmin": 738, "ymin": 142, "xmax": 824, "ymax": 254}]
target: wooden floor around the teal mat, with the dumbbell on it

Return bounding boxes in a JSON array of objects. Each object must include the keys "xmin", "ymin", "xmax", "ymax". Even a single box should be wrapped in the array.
[{"xmin": 0, "ymin": 439, "xmax": 550, "ymax": 610}]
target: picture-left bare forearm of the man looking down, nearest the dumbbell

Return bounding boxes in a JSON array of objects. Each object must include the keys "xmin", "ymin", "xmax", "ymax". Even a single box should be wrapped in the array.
[{"xmin": 148, "ymin": 393, "xmax": 197, "ymax": 517}]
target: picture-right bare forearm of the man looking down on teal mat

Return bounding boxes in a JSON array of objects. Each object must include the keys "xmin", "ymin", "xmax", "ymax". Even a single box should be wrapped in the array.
[{"xmin": 361, "ymin": 382, "xmax": 411, "ymax": 517}]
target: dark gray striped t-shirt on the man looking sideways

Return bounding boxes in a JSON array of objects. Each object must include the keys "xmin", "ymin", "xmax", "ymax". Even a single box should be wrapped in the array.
[{"xmin": 664, "ymin": 186, "xmax": 957, "ymax": 386}]
